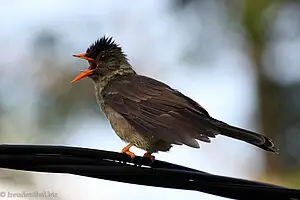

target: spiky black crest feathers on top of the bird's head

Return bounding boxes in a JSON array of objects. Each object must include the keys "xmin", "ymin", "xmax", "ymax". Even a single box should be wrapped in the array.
[{"xmin": 86, "ymin": 36, "xmax": 122, "ymax": 58}]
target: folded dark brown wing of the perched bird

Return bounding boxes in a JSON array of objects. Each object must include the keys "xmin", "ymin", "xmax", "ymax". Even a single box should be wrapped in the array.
[{"xmin": 103, "ymin": 75, "xmax": 218, "ymax": 148}]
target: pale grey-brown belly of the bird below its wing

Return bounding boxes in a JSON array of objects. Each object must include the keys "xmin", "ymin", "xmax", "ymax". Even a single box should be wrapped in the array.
[{"xmin": 101, "ymin": 105, "xmax": 172, "ymax": 153}]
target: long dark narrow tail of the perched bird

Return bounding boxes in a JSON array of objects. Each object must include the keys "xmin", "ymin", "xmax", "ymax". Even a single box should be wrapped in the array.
[{"xmin": 210, "ymin": 119, "xmax": 279, "ymax": 154}]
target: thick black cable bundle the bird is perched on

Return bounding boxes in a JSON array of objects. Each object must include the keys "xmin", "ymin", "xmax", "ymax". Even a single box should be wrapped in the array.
[{"xmin": 0, "ymin": 145, "xmax": 300, "ymax": 199}]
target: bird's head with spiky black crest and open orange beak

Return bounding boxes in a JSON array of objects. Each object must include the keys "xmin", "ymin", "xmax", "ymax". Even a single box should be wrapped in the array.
[{"xmin": 72, "ymin": 36, "xmax": 130, "ymax": 83}]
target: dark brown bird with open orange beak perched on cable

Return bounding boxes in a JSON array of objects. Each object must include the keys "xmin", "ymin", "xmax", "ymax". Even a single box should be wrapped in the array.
[{"xmin": 71, "ymin": 36, "xmax": 279, "ymax": 161}]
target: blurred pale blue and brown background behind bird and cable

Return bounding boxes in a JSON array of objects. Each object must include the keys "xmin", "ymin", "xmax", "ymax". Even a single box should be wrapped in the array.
[{"xmin": 0, "ymin": 0, "xmax": 300, "ymax": 200}]
